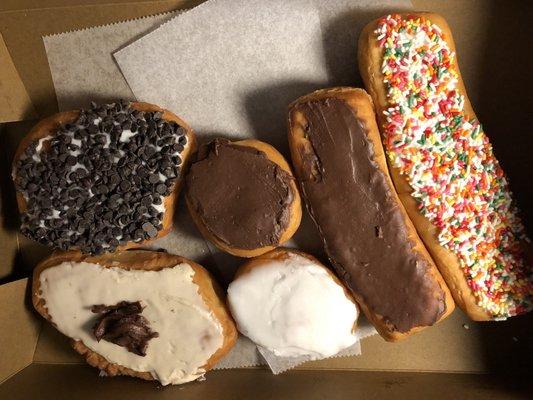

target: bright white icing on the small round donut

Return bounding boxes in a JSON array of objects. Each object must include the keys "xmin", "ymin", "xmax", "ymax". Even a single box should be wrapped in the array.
[{"xmin": 228, "ymin": 254, "xmax": 358, "ymax": 359}]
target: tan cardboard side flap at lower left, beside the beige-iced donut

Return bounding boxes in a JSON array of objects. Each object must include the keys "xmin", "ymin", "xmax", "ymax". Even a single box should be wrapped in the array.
[{"xmin": 0, "ymin": 279, "xmax": 41, "ymax": 384}]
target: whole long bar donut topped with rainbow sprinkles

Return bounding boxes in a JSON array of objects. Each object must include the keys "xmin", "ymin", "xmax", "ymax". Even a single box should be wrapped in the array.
[{"xmin": 359, "ymin": 13, "xmax": 533, "ymax": 321}]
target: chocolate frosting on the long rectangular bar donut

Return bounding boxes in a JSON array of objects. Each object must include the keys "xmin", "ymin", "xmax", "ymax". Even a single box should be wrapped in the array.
[{"xmin": 290, "ymin": 98, "xmax": 446, "ymax": 332}]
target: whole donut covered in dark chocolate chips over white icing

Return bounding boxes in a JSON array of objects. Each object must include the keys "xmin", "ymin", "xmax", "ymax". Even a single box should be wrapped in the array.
[{"xmin": 12, "ymin": 101, "xmax": 196, "ymax": 254}]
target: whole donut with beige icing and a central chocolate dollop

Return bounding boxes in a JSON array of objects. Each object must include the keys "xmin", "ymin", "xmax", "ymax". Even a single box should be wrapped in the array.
[{"xmin": 32, "ymin": 250, "xmax": 237, "ymax": 385}]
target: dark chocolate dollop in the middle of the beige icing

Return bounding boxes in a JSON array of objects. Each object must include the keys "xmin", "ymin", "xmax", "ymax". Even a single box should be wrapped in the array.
[{"xmin": 91, "ymin": 301, "xmax": 159, "ymax": 357}]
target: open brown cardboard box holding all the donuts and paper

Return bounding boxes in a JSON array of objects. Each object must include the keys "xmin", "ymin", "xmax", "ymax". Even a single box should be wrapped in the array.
[{"xmin": 0, "ymin": 0, "xmax": 533, "ymax": 399}]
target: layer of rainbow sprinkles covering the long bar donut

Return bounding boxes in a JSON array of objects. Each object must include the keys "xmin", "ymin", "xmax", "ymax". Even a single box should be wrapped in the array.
[{"xmin": 375, "ymin": 15, "xmax": 533, "ymax": 319}]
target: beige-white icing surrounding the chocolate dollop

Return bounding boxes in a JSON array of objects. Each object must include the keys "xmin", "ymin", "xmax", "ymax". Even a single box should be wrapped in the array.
[{"xmin": 39, "ymin": 262, "xmax": 223, "ymax": 385}]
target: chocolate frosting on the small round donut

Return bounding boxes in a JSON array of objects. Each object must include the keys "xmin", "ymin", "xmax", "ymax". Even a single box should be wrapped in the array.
[{"xmin": 186, "ymin": 139, "xmax": 293, "ymax": 249}]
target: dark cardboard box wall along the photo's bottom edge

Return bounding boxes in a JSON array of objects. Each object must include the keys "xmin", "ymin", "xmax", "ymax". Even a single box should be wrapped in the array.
[{"xmin": 0, "ymin": 364, "xmax": 532, "ymax": 400}]
